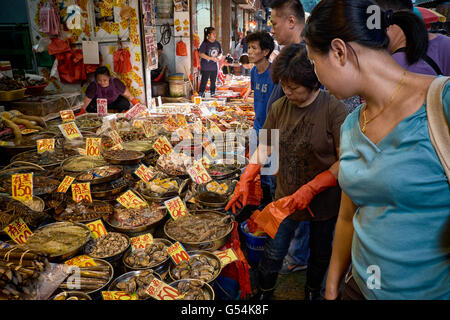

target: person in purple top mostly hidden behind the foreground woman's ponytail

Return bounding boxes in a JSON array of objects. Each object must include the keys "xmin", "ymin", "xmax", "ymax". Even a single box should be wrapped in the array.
[{"xmin": 375, "ymin": 0, "xmax": 450, "ymax": 76}]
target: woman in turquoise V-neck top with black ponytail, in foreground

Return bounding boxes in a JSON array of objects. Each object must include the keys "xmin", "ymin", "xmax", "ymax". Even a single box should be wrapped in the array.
[{"xmin": 303, "ymin": 0, "xmax": 450, "ymax": 300}]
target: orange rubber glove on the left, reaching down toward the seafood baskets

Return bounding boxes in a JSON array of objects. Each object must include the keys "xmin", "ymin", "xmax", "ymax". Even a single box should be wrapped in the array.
[{"xmin": 225, "ymin": 164, "xmax": 262, "ymax": 214}]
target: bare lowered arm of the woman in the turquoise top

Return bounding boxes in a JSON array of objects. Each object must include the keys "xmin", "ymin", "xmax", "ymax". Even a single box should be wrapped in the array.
[{"xmin": 325, "ymin": 192, "xmax": 357, "ymax": 300}]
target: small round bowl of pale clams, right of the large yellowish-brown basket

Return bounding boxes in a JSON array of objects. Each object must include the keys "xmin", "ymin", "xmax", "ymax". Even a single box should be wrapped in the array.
[{"xmin": 86, "ymin": 232, "xmax": 130, "ymax": 259}]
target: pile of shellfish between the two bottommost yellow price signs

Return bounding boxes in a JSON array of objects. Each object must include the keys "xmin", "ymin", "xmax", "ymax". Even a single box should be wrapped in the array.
[{"xmin": 110, "ymin": 269, "xmax": 159, "ymax": 300}]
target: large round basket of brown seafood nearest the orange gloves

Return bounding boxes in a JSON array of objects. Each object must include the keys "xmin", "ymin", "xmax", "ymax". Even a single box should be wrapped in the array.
[{"xmin": 164, "ymin": 212, "xmax": 236, "ymax": 243}]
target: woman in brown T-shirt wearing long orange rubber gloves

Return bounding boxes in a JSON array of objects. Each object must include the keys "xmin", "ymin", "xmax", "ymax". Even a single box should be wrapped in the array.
[{"xmin": 227, "ymin": 44, "xmax": 347, "ymax": 300}]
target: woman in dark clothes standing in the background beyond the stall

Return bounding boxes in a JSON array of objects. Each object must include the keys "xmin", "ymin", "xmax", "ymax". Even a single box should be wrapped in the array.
[{"xmin": 198, "ymin": 27, "xmax": 222, "ymax": 96}]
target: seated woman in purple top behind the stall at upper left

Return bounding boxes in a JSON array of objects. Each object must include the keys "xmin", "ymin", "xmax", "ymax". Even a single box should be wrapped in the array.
[{"xmin": 77, "ymin": 67, "xmax": 139, "ymax": 115}]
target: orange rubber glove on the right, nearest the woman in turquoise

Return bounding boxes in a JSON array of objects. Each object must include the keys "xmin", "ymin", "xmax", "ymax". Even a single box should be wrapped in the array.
[{"xmin": 278, "ymin": 170, "xmax": 337, "ymax": 213}]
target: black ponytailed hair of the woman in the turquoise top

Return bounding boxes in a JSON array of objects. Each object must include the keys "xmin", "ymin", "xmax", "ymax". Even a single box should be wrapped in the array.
[{"xmin": 302, "ymin": 0, "xmax": 428, "ymax": 64}]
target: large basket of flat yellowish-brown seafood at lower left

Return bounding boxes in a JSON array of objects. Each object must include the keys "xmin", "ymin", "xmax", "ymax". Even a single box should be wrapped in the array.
[{"xmin": 22, "ymin": 222, "xmax": 91, "ymax": 258}]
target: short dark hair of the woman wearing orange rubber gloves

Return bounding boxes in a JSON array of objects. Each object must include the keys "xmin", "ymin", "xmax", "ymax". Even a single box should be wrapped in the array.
[{"xmin": 272, "ymin": 43, "xmax": 320, "ymax": 91}]
